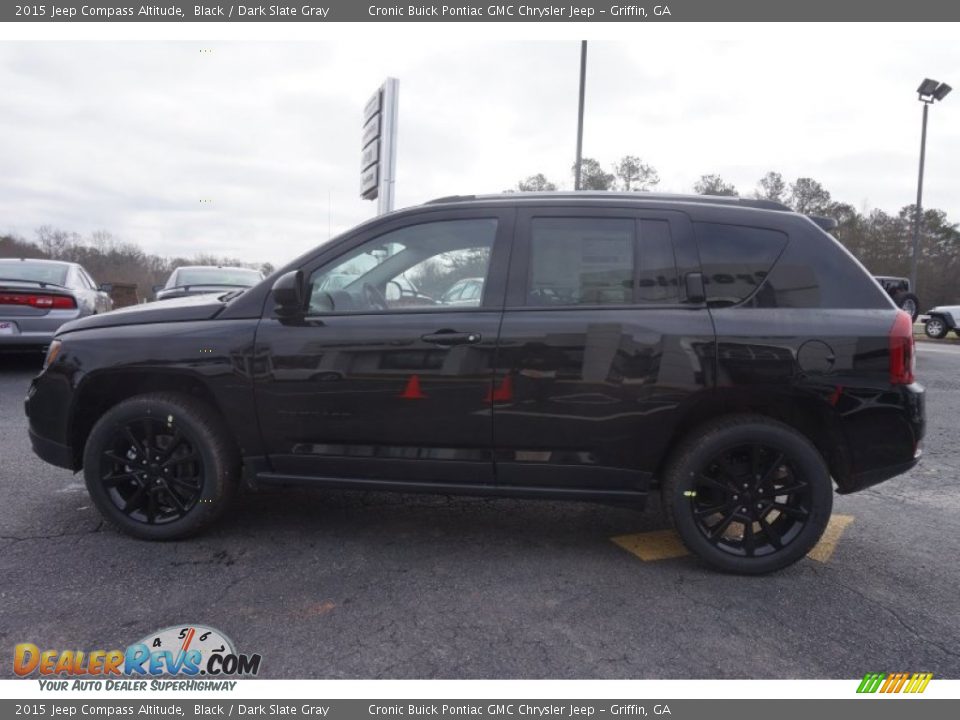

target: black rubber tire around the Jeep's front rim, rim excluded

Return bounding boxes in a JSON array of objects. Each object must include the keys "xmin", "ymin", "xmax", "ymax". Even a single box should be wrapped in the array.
[{"xmin": 83, "ymin": 398, "xmax": 228, "ymax": 540}]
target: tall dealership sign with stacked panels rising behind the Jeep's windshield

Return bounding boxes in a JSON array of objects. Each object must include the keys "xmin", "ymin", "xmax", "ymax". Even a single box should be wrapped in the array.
[{"xmin": 360, "ymin": 78, "xmax": 400, "ymax": 215}]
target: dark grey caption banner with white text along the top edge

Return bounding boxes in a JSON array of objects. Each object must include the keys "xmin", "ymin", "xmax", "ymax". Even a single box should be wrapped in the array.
[{"xmin": 0, "ymin": 0, "xmax": 960, "ymax": 22}]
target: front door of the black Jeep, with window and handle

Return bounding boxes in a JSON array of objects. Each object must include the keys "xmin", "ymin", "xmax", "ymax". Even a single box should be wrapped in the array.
[{"xmin": 255, "ymin": 209, "xmax": 513, "ymax": 490}]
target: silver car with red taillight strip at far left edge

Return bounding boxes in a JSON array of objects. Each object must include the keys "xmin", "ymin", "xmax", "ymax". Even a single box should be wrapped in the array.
[{"xmin": 0, "ymin": 258, "xmax": 113, "ymax": 350}]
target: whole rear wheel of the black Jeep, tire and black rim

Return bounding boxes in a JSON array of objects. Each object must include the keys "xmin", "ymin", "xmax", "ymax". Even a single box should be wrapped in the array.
[{"xmin": 661, "ymin": 415, "xmax": 833, "ymax": 575}]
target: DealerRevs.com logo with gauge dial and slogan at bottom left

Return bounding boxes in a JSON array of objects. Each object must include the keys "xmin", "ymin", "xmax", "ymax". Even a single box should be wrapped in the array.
[{"xmin": 13, "ymin": 625, "xmax": 261, "ymax": 690}]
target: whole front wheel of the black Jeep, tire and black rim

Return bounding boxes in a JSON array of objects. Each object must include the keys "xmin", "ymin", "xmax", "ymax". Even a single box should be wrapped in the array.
[{"xmin": 83, "ymin": 393, "xmax": 240, "ymax": 540}]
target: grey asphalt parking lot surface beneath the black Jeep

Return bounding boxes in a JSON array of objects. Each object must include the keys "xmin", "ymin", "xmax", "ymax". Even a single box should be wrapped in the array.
[{"xmin": 0, "ymin": 343, "xmax": 960, "ymax": 678}]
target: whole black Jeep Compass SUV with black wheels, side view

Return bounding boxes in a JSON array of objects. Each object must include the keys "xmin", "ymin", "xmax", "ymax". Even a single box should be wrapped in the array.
[{"xmin": 26, "ymin": 193, "xmax": 924, "ymax": 573}]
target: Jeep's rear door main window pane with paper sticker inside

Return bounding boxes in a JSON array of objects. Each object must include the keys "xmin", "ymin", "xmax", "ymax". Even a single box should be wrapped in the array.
[{"xmin": 527, "ymin": 218, "xmax": 636, "ymax": 305}]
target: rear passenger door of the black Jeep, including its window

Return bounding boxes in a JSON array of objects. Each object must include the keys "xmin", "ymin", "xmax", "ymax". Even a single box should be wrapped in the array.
[{"xmin": 493, "ymin": 206, "xmax": 714, "ymax": 490}]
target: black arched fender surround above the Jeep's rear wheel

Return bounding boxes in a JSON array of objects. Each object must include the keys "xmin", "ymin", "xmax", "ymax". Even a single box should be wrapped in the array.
[{"xmin": 654, "ymin": 388, "xmax": 851, "ymax": 489}]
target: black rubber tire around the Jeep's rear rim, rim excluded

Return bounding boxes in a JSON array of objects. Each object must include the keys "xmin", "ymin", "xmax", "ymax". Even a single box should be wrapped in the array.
[{"xmin": 664, "ymin": 422, "xmax": 833, "ymax": 574}]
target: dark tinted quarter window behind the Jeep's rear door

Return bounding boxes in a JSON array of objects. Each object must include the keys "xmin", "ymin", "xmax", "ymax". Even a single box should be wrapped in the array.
[{"xmin": 694, "ymin": 223, "xmax": 787, "ymax": 306}]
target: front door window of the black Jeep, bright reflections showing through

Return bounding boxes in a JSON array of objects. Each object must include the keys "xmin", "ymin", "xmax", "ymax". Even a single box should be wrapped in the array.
[{"xmin": 308, "ymin": 218, "xmax": 497, "ymax": 315}]
